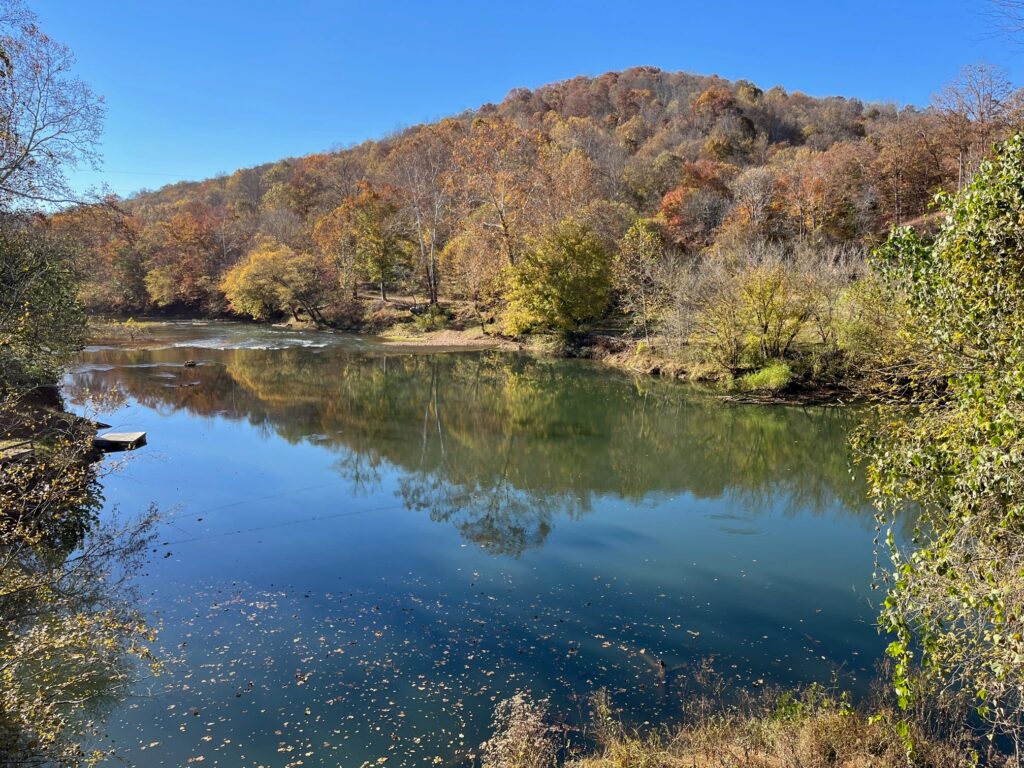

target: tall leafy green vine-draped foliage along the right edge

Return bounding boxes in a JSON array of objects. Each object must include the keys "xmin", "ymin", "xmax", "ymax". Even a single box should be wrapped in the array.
[{"xmin": 858, "ymin": 135, "xmax": 1024, "ymax": 764}]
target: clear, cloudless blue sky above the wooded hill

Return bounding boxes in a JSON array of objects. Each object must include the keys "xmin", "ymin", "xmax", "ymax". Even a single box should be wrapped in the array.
[{"xmin": 34, "ymin": 0, "xmax": 1024, "ymax": 195}]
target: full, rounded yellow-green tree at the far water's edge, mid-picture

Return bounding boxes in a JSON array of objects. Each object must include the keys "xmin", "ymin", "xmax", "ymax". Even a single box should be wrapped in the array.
[{"xmin": 505, "ymin": 219, "xmax": 611, "ymax": 334}]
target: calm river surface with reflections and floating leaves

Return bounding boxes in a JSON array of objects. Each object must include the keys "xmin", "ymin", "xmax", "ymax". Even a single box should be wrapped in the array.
[{"xmin": 66, "ymin": 324, "xmax": 883, "ymax": 768}]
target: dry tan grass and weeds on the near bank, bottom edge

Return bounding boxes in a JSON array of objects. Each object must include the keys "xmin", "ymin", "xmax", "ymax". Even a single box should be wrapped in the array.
[{"xmin": 485, "ymin": 687, "xmax": 983, "ymax": 768}]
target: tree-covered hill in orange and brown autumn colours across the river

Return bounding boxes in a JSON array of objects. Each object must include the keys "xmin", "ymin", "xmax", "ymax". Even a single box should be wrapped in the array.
[{"xmin": 58, "ymin": 66, "xmax": 1021, "ymax": 368}]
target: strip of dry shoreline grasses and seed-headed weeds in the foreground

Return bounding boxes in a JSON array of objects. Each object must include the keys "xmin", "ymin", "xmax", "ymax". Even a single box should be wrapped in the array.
[{"xmin": 480, "ymin": 684, "xmax": 974, "ymax": 768}]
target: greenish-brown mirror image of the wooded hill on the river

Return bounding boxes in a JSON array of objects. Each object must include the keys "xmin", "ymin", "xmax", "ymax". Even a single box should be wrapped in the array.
[{"xmin": 64, "ymin": 349, "xmax": 862, "ymax": 552}]
